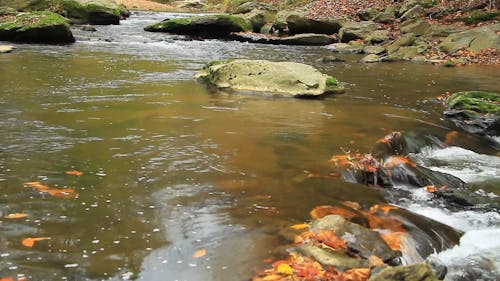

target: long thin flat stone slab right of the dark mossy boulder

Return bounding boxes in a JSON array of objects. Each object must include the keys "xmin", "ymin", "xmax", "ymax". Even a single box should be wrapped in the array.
[{"xmin": 230, "ymin": 32, "xmax": 337, "ymax": 46}]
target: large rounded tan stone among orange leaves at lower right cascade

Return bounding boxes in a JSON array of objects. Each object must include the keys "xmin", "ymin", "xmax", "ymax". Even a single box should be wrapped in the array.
[{"xmin": 311, "ymin": 215, "xmax": 400, "ymax": 261}]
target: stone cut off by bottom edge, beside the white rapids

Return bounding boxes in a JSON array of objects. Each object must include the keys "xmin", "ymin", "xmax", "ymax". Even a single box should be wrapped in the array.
[{"xmin": 368, "ymin": 263, "xmax": 438, "ymax": 281}]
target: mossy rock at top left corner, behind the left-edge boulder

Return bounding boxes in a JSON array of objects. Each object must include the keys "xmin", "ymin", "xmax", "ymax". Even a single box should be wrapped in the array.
[{"xmin": 2, "ymin": 0, "xmax": 129, "ymax": 24}]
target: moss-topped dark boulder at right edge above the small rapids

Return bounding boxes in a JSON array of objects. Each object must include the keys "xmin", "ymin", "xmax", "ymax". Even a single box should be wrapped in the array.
[{"xmin": 444, "ymin": 91, "xmax": 500, "ymax": 136}]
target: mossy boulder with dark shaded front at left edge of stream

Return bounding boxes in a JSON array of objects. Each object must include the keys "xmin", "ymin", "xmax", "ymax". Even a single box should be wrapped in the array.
[{"xmin": 0, "ymin": 11, "xmax": 75, "ymax": 43}]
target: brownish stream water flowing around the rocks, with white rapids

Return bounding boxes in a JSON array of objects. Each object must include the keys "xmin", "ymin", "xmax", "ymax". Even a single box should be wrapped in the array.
[{"xmin": 0, "ymin": 12, "xmax": 500, "ymax": 280}]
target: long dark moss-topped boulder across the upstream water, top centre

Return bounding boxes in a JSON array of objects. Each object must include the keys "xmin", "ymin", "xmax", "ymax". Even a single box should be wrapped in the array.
[{"xmin": 144, "ymin": 15, "xmax": 253, "ymax": 37}]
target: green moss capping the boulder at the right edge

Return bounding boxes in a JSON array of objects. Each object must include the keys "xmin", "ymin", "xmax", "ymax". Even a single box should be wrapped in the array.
[{"xmin": 447, "ymin": 91, "xmax": 500, "ymax": 115}]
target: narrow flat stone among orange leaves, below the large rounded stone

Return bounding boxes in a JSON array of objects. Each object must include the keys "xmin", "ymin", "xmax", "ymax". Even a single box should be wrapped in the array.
[{"xmin": 294, "ymin": 244, "xmax": 368, "ymax": 271}]
